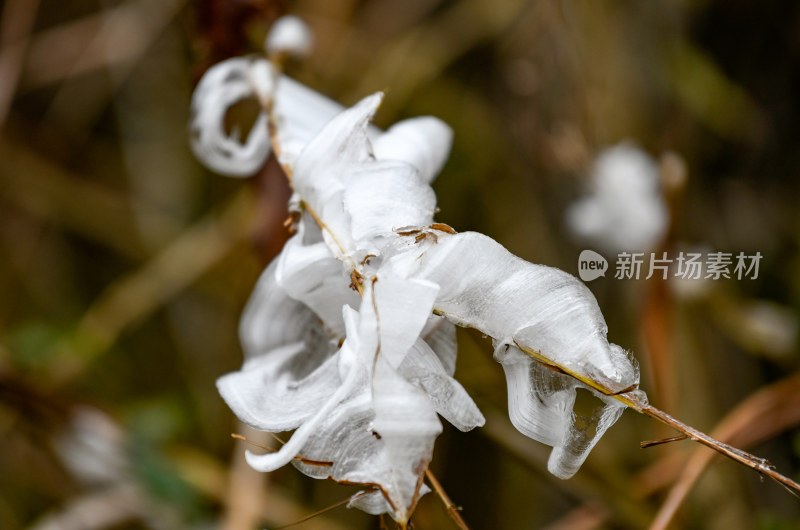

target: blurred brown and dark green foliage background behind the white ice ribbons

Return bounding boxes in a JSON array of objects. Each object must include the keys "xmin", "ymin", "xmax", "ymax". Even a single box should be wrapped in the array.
[{"xmin": 0, "ymin": 0, "xmax": 800, "ymax": 530}]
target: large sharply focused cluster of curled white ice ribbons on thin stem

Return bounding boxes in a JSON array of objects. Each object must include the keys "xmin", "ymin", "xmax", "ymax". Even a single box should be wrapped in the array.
[{"xmin": 191, "ymin": 15, "xmax": 639, "ymax": 525}]
